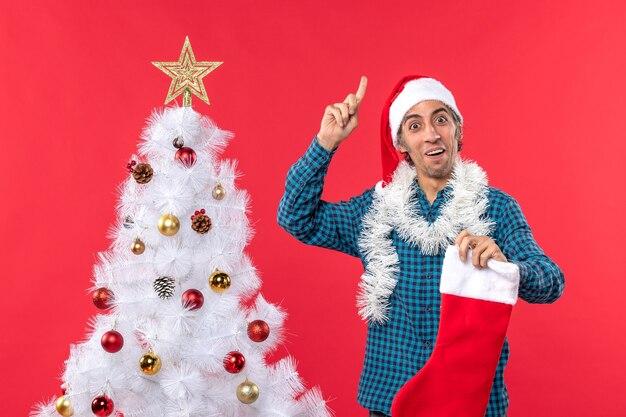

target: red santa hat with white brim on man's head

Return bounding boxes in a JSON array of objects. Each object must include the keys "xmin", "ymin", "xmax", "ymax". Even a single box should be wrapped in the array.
[{"xmin": 380, "ymin": 75, "xmax": 463, "ymax": 185}]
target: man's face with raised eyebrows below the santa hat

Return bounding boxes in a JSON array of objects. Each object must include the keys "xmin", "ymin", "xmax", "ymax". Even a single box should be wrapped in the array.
[{"xmin": 398, "ymin": 100, "xmax": 458, "ymax": 179}]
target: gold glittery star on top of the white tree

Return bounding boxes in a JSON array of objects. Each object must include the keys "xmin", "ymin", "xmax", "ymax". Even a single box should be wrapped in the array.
[{"xmin": 152, "ymin": 36, "xmax": 223, "ymax": 107}]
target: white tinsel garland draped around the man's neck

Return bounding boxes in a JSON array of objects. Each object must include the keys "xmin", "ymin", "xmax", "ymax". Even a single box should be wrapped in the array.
[{"xmin": 357, "ymin": 159, "xmax": 492, "ymax": 324}]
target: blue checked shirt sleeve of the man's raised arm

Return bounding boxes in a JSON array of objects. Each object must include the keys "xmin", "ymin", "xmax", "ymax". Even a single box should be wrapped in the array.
[{"xmin": 278, "ymin": 138, "xmax": 373, "ymax": 256}]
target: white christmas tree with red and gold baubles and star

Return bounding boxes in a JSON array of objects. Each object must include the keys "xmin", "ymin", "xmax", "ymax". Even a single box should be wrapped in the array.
[{"xmin": 31, "ymin": 39, "xmax": 330, "ymax": 417}]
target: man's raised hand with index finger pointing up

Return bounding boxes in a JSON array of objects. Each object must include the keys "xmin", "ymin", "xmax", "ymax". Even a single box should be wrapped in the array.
[{"xmin": 317, "ymin": 76, "xmax": 367, "ymax": 151}]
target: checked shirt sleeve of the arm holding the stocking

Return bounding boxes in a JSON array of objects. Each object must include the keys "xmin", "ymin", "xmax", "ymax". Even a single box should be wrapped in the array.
[{"xmin": 499, "ymin": 198, "xmax": 565, "ymax": 303}]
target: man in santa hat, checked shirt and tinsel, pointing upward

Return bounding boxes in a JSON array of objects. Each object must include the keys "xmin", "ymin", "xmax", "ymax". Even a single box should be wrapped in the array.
[{"xmin": 278, "ymin": 76, "xmax": 564, "ymax": 416}]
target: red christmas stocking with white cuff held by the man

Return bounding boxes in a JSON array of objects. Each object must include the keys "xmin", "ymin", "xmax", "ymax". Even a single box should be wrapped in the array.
[{"xmin": 391, "ymin": 246, "xmax": 519, "ymax": 417}]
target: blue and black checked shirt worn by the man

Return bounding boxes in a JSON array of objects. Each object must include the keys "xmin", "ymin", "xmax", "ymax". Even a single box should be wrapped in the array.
[{"xmin": 278, "ymin": 139, "xmax": 564, "ymax": 417}]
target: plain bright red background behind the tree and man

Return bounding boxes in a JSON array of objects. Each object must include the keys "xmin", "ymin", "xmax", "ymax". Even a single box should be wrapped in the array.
[{"xmin": 0, "ymin": 0, "xmax": 626, "ymax": 417}]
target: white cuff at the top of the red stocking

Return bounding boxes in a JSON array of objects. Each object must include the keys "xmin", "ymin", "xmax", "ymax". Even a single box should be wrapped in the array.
[{"xmin": 439, "ymin": 246, "xmax": 519, "ymax": 305}]
